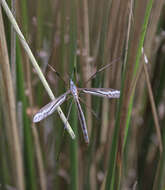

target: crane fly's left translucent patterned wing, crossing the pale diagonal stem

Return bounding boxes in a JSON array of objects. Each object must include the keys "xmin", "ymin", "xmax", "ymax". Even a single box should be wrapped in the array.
[{"xmin": 33, "ymin": 90, "xmax": 70, "ymax": 123}]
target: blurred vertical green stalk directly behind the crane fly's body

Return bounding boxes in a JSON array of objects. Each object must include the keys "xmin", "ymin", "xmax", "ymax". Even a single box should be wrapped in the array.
[{"xmin": 69, "ymin": 0, "xmax": 78, "ymax": 190}]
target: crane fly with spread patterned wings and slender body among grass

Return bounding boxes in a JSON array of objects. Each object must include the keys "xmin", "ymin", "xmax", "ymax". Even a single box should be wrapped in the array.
[{"xmin": 33, "ymin": 80, "xmax": 120, "ymax": 143}]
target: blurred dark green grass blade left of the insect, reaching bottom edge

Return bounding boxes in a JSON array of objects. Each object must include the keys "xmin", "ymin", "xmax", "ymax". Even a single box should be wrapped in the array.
[{"xmin": 16, "ymin": 40, "xmax": 37, "ymax": 190}]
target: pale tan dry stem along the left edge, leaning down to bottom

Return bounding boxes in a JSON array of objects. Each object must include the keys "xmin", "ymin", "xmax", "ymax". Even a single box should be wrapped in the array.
[{"xmin": 0, "ymin": 6, "xmax": 24, "ymax": 190}]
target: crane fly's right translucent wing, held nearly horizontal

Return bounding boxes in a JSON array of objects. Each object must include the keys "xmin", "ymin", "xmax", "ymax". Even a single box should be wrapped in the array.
[{"xmin": 78, "ymin": 88, "xmax": 120, "ymax": 98}]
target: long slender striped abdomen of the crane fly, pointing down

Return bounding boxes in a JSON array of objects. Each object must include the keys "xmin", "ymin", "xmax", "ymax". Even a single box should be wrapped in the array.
[{"xmin": 75, "ymin": 99, "xmax": 89, "ymax": 144}]
